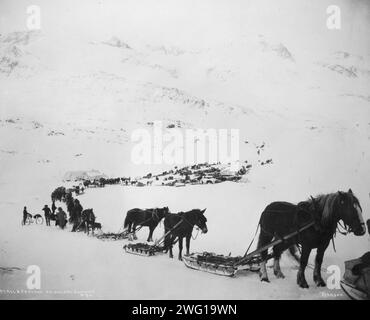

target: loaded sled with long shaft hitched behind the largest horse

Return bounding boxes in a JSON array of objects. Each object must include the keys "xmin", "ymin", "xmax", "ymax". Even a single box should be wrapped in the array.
[{"xmin": 183, "ymin": 222, "xmax": 315, "ymax": 277}]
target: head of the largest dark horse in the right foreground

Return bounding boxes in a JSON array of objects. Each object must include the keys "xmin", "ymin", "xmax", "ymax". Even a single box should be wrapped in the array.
[{"xmin": 338, "ymin": 189, "xmax": 366, "ymax": 236}]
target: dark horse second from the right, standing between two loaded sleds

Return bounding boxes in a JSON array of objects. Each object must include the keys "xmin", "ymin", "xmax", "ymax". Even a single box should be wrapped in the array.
[{"xmin": 164, "ymin": 209, "xmax": 208, "ymax": 260}]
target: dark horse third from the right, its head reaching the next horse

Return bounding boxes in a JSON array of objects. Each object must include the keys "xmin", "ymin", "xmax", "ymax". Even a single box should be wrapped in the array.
[{"xmin": 124, "ymin": 207, "xmax": 169, "ymax": 242}]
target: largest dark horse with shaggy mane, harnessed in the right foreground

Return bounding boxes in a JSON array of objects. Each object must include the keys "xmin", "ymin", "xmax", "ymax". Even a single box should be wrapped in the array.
[{"xmin": 257, "ymin": 189, "xmax": 366, "ymax": 288}]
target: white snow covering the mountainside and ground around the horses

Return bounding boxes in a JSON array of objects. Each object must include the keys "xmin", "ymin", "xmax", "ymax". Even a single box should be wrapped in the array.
[{"xmin": 0, "ymin": 0, "xmax": 370, "ymax": 299}]
